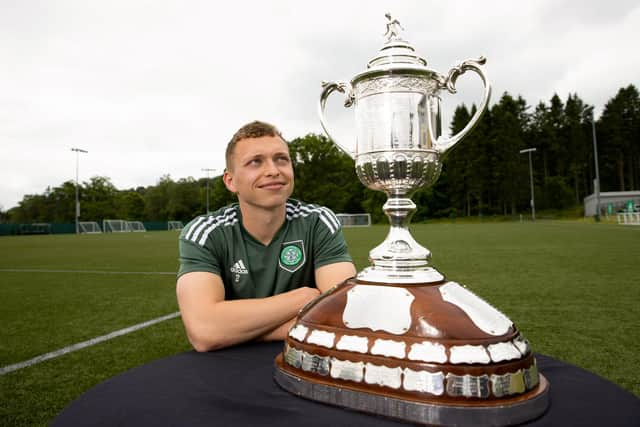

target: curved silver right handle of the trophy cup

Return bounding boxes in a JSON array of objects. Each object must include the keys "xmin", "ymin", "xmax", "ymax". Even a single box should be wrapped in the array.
[{"xmin": 435, "ymin": 56, "xmax": 491, "ymax": 154}]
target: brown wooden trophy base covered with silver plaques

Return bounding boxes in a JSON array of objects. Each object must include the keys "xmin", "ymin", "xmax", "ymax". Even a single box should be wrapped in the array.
[{"xmin": 274, "ymin": 274, "xmax": 549, "ymax": 426}]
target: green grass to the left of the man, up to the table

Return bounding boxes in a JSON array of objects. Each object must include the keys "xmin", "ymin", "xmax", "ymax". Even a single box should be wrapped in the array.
[{"xmin": 0, "ymin": 232, "xmax": 189, "ymax": 426}]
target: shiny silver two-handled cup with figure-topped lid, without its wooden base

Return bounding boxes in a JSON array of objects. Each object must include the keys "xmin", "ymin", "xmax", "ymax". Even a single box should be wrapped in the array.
[{"xmin": 319, "ymin": 14, "xmax": 491, "ymax": 283}]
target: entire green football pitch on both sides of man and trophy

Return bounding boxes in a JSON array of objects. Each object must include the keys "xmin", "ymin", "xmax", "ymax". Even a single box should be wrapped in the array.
[{"xmin": 0, "ymin": 222, "xmax": 640, "ymax": 426}]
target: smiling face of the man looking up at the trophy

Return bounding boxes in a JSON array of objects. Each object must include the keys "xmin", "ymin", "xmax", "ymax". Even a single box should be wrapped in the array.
[{"xmin": 224, "ymin": 136, "xmax": 293, "ymax": 209}]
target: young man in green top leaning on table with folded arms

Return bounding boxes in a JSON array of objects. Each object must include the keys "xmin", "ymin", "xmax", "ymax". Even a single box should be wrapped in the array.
[{"xmin": 176, "ymin": 122, "xmax": 355, "ymax": 351}]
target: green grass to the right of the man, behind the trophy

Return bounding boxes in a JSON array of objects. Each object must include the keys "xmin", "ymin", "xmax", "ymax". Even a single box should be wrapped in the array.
[{"xmin": 348, "ymin": 222, "xmax": 640, "ymax": 396}]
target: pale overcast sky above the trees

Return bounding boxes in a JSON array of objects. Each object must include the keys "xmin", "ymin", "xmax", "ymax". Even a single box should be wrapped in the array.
[{"xmin": 0, "ymin": 0, "xmax": 640, "ymax": 210}]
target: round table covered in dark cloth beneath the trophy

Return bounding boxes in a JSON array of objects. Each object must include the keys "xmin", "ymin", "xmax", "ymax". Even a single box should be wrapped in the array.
[{"xmin": 52, "ymin": 342, "xmax": 640, "ymax": 427}]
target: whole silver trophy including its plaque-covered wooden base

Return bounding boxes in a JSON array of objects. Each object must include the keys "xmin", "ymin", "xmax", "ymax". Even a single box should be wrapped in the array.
[{"xmin": 274, "ymin": 15, "xmax": 549, "ymax": 426}]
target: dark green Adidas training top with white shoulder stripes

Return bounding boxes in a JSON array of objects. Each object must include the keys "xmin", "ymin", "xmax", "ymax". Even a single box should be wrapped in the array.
[{"xmin": 178, "ymin": 199, "xmax": 351, "ymax": 300}]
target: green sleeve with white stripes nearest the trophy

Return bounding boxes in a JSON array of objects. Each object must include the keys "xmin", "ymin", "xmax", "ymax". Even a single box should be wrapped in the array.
[{"xmin": 313, "ymin": 208, "xmax": 353, "ymax": 268}]
